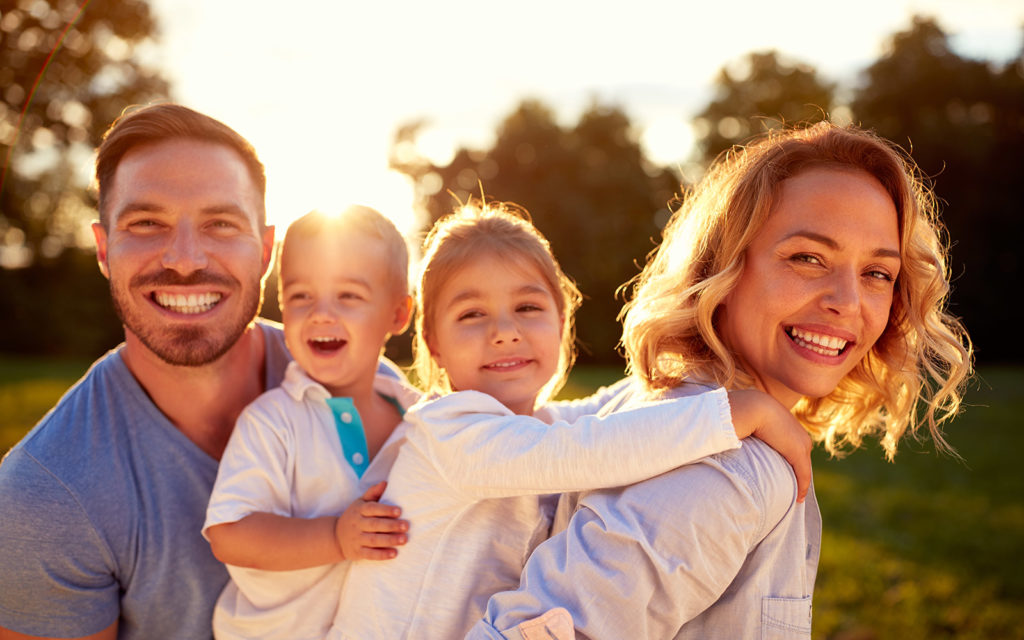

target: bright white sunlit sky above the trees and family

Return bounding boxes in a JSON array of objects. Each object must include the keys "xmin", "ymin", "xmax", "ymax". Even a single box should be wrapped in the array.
[{"xmin": 144, "ymin": 0, "xmax": 1024, "ymax": 231}]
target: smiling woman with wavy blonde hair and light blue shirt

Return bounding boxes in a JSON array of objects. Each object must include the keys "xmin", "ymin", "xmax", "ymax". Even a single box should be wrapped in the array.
[{"xmin": 469, "ymin": 123, "xmax": 971, "ymax": 639}]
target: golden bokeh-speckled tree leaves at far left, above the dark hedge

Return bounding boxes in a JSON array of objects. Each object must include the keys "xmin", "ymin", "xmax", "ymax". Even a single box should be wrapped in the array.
[{"xmin": 0, "ymin": 0, "xmax": 167, "ymax": 266}]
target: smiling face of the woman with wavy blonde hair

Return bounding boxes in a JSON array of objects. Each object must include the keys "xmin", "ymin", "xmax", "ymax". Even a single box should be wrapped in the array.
[{"xmin": 719, "ymin": 168, "xmax": 900, "ymax": 408}]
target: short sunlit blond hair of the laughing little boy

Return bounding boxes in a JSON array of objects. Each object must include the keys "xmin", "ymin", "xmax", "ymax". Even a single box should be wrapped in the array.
[{"xmin": 276, "ymin": 205, "xmax": 409, "ymax": 301}]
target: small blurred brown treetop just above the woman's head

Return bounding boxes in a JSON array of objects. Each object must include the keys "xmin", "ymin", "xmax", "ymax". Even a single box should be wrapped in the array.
[{"xmin": 693, "ymin": 51, "xmax": 835, "ymax": 165}]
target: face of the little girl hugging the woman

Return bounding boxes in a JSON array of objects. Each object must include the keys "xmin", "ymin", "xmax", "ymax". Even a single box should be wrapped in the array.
[{"xmin": 427, "ymin": 256, "xmax": 562, "ymax": 415}]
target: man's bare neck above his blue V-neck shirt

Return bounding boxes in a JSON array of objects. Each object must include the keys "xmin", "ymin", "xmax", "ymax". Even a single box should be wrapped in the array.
[{"xmin": 121, "ymin": 324, "xmax": 266, "ymax": 460}]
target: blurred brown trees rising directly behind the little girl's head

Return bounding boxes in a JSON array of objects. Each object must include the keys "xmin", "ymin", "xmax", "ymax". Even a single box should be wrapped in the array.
[{"xmin": 391, "ymin": 100, "xmax": 679, "ymax": 362}]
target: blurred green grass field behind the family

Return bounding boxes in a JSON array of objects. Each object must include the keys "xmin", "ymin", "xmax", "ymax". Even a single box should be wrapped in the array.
[{"xmin": 0, "ymin": 358, "xmax": 1024, "ymax": 640}]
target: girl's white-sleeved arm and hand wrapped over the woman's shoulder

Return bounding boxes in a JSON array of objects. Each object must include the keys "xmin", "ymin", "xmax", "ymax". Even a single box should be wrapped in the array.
[{"xmin": 407, "ymin": 389, "xmax": 810, "ymax": 499}]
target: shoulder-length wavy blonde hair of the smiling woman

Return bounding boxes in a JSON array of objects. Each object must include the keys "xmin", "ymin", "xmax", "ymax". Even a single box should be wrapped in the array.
[{"xmin": 621, "ymin": 122, "xmax": 972, "ymax": 460}]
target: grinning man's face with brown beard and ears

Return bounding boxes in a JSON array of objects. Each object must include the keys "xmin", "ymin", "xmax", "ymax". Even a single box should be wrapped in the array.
[{"xmin": 93, "ymin": 140, "xmax": 273, "ymax": 367}]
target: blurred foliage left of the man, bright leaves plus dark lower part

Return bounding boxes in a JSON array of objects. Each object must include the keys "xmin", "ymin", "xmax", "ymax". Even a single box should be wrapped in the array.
[{"xmin": 0, "ymin": 0, "xmax": 168, "ymax": 355}]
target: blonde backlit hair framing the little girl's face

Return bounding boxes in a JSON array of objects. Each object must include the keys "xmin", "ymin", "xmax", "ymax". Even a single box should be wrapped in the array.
[{"xmin": 413, "ymin": 200, "xmax": 581, "ymax": 407}]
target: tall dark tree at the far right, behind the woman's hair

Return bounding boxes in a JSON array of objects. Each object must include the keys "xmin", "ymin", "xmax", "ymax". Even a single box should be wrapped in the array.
[{"xmin": 851, "ymin": 16, "xmax": 1024, "ymax": 361}]
